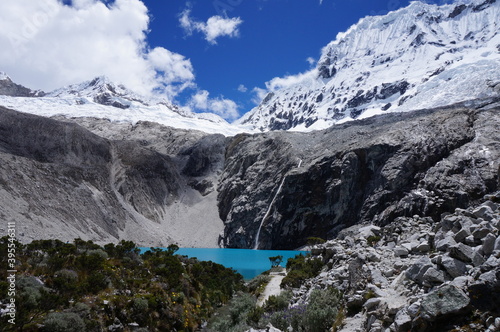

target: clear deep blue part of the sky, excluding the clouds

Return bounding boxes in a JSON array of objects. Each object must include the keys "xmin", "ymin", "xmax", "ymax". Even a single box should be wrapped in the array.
[{"xmin": 144, "ymin": 0, "xmax": 414, "ymax": 114}]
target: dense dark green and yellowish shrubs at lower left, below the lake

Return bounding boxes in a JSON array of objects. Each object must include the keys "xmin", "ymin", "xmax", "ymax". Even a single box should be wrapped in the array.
[{"xmin": 0, "ymin": 237, "xmax": 244, "ymax": 332}]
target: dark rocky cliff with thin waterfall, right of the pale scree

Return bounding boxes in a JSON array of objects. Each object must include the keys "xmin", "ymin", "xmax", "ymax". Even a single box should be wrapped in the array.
[{"xmin": 218, "ymin": 101, "xmax": 500, "ymax": 249}]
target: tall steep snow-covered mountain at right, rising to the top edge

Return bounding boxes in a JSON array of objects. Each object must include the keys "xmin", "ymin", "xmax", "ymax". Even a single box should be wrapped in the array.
[{"xmin": 238, "ymin": 0, "xmax": 500, "ymax": 131}]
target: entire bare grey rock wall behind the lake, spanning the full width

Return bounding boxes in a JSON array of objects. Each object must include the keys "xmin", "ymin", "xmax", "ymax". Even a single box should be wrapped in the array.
[{"xmin": 0, "ymin": 100, "xmax": 500, "ymax": 249}]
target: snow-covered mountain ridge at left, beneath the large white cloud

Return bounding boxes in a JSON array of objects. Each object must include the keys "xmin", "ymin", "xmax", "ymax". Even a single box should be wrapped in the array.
[{"xmin": 0, "ymin": 73, "xmax": 244, "ymax": 135}]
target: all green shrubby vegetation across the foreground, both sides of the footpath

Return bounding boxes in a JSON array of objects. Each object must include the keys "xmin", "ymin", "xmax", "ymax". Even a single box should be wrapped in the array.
[{"xmin": 0, "ymin": 237, "xmax": 343, "ymax": 332}]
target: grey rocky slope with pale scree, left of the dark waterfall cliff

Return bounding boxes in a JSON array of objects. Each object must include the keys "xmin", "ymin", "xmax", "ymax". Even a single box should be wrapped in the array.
[{"xmin": 0, "ymin": 107, "xmax": 225, "ymax": 247}]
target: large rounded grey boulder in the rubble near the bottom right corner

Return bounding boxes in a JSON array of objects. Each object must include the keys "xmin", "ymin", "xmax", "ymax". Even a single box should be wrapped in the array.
[{"xmin": 421, "ymin": 285, "xmax": 470, "ymax": 320}]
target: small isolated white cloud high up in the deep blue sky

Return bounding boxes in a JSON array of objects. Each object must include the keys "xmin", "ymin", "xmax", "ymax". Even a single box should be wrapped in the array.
[{"xmin": 179, "ymin": 9, "xmax": 243, "ymax": 45}]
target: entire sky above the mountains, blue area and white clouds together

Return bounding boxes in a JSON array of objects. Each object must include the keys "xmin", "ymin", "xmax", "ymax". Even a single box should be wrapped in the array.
[{"xmin": 0, "ymin": 0, "xmax": 458, "ymax": 121}]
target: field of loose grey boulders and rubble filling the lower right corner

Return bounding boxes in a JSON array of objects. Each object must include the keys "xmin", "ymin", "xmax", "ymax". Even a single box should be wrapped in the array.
[{"xmin": 291, "ymin": 192, "xmax": 500, "ymax": 332}]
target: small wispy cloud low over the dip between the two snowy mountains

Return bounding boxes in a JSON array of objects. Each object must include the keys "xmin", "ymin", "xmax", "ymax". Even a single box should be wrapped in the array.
[{"xmin": 189, "ymin": 90, "xmax": 239, "ymax": 120}]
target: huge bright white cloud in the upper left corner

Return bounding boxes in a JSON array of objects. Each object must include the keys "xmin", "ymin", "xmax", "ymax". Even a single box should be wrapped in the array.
[{"xmin": 0, "ymin": 0, "xmax": 195, "ymax": 99}]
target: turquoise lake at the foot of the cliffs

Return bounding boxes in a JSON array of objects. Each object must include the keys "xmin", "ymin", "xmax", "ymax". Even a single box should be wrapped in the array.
[{"xmin": 141, "ymin": 248, "xmax": 307, "ymax": 280}]
